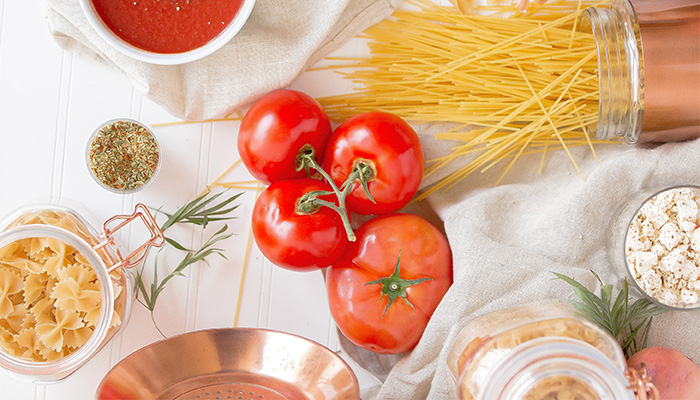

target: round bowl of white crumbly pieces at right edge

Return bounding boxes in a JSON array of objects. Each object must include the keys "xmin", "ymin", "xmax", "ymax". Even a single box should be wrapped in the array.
[{"xmin": 611, "ymin": 185, "xmax": 700, "ymax": 310}]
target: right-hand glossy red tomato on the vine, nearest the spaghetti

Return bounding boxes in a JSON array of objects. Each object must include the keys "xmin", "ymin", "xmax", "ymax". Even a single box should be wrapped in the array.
[{"xmin": 323, "ymin": 111, "xmax": 424, "ymax": 215}]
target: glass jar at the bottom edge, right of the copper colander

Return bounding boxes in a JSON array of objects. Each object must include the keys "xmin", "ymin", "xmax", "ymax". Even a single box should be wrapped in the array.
[{"xmin": 447, "ymin": 300, "xmax": 656, "ymax": 400}]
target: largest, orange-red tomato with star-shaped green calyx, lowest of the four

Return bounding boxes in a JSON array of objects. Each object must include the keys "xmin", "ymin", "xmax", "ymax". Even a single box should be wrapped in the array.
[{"xmin": 326, "ymin": 214, "xmax": 452, "ymax": 354}]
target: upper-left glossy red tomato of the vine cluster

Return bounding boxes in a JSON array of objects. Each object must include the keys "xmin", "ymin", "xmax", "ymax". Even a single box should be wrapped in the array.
[{"xmin": 238, "ymin": 89, "xmax": 332, "ymax": 184}]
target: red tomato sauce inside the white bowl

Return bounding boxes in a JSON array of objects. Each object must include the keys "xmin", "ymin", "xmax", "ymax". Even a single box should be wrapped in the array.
[{"xmin": 92, "ymin": 0, "xmax": 243, "ymax": 53}]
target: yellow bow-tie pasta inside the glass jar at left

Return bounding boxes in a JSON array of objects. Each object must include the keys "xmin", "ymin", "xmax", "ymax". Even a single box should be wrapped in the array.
[{"xmin": 0, "ymin": 210, "xmax": 126, "ymax": 362}]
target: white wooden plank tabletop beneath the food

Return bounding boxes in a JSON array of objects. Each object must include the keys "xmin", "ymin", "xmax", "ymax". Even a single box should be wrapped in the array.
[{"xmin": 0, "ymin": 0, "xmax": 447, "ymax": 400}]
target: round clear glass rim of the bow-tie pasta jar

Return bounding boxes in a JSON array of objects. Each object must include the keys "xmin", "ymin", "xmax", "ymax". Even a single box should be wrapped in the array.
[{"xmin": 0, "ymin": 224, "xmax": 115, "ymax": 382}]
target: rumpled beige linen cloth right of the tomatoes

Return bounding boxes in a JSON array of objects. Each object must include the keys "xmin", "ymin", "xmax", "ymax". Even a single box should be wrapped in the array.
[{"xmin": 358, "ymin": 133, "xmax": 700, "ymax": 400}]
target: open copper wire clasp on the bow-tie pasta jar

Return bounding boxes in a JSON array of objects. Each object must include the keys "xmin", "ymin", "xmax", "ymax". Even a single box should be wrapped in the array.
[{"xmin": 93, "ymin": 203, "xmax": 165, "ymax": 272}]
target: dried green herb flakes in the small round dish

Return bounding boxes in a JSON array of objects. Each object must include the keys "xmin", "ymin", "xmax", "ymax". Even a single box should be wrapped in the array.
[{"xmin": 88, "ymin": 121, "xmax": 160, "ymax": 191}]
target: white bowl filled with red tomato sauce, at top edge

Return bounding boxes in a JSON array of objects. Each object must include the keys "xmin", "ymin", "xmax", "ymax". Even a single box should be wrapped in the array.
[{"xmin": 78, "ymin": 0, "xmax": 255, "ymax": 65}]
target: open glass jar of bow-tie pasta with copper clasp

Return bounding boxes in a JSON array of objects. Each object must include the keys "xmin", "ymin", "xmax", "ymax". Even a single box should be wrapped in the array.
[{"xmin": 0, "ymin": 204, "xmax": 164, "ymax": 383}]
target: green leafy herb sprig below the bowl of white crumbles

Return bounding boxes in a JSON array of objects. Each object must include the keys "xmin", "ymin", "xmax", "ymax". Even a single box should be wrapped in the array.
[{"xmin": 552, "ymin": 271, "xmax": 666, "ymax": 358}]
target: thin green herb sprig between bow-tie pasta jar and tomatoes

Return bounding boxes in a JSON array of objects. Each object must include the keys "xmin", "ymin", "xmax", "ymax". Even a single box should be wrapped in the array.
[{"xmin": 136, "ymin": 192, "xmax": 241, "ymax": 336}]
